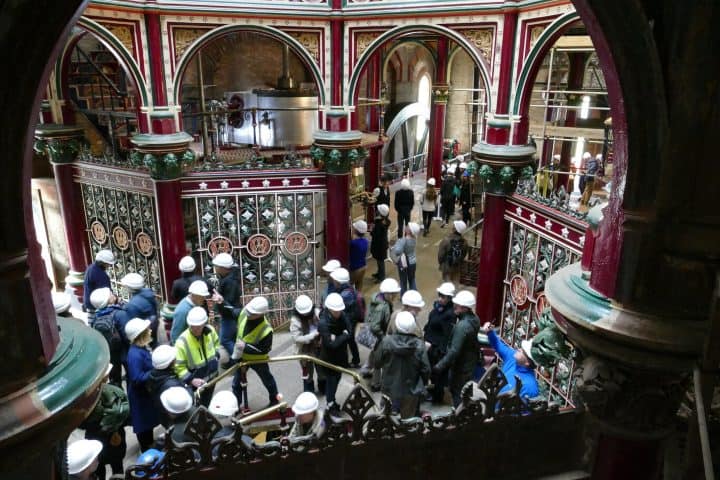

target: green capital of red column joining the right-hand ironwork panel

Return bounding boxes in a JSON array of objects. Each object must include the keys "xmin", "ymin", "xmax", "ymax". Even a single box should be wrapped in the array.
[{"xmin": 472, "ymin": 143, "xmax": 536, "ymax": 195}]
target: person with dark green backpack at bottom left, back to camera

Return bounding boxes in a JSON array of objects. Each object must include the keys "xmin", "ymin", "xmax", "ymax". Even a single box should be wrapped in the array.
[{"xmin": 79, "ymin": 364, "xmax": 130, "ymax": 478}]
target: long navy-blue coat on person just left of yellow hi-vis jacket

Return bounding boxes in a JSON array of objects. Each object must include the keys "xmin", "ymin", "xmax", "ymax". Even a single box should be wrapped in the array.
[{"xmin": 127, "ymin": 345, "xmax": 160, "ymax": 433}]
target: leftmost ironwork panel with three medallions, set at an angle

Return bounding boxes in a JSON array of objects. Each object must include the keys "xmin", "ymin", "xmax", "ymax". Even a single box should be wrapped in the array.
[{"xmin": 80, "ymin": 183, "xmax": 163, "ymax": 297}]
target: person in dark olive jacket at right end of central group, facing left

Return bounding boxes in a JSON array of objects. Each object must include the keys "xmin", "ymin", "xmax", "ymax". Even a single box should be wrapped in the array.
[{"xmin": 433, "ymin": 290, "xmax": 480, "ymax": 407}]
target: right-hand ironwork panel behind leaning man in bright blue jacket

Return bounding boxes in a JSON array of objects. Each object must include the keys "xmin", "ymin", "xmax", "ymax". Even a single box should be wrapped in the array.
[{"xmin": 500, "ymin": 221, "xmax": 581, "ymax": 407}]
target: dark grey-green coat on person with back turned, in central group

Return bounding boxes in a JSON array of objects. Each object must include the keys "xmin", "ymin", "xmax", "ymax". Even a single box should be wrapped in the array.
[{"xmin": 376, "ymin": 333, "xmax": 430, "ymax": 400}]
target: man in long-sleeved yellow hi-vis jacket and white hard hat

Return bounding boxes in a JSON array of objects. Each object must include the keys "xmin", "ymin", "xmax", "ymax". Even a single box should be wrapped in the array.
[{"xmin": 175, "ymin": 307, "xmax": 220, "ymax": 406}]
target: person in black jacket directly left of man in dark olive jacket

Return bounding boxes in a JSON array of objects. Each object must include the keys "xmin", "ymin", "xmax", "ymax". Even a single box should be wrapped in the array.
[{"xmin": 423, "ymin": 282, "xmax": 457, "ymax": 404}]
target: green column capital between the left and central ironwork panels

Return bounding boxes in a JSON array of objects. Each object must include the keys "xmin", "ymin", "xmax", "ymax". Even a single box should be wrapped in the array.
[{"xmin": 130, "ymin": 132, "xmax": 195, "ymax": 180}]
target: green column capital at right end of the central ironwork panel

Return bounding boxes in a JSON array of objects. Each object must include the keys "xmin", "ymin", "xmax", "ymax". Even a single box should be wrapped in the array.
[{"xmin": 310, "ymin": 130, "xmax": 367, "ymax": 175}]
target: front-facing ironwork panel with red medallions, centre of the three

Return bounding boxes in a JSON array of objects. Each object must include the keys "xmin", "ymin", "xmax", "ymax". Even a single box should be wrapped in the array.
[{"xmin": 184, "ymin": 191, "xmax": 324, "ymax": 326}]
